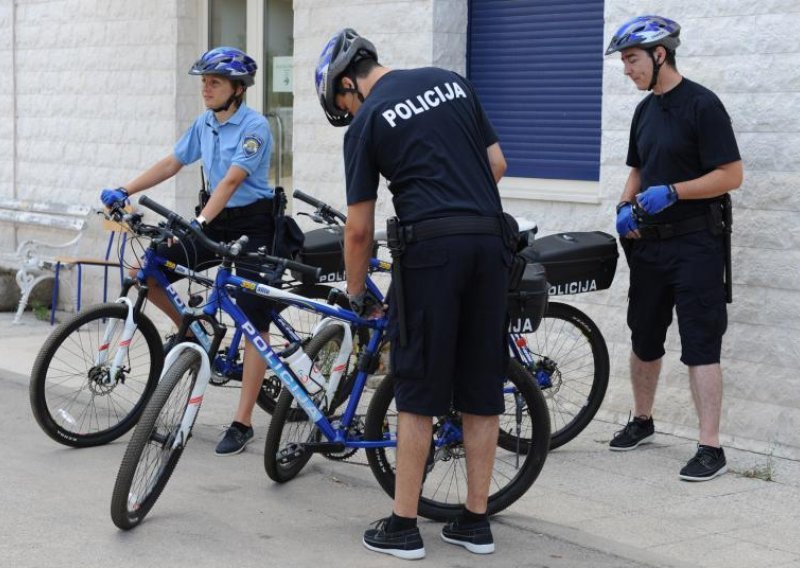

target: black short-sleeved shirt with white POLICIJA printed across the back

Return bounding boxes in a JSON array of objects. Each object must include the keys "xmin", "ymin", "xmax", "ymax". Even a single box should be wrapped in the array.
[{"xmin": 344, "ymin": 67, "xmax": 502, "ymax": 223}]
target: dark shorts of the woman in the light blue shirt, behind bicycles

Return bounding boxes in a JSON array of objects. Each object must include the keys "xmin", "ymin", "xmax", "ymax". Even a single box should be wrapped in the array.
[{"xmin": 158, "ymin": 206, "xmax": 276, "ymax": 331}]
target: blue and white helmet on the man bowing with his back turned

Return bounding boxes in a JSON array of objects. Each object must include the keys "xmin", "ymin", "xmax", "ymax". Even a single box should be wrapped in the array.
[{"xmin": 314, "ymin": 28, "xmax": 378, "ymax": 126}]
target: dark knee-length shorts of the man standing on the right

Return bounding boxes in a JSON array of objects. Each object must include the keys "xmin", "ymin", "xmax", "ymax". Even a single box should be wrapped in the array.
[{"xmin": 628, "ymin": 231, "xmax": 728, "ymax": 366}]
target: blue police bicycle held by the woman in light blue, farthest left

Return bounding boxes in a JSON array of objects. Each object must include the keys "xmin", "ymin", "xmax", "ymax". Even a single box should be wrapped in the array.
[{"xmin": 29, "ymin": 202, "xmax": 348, "ymax": 447}]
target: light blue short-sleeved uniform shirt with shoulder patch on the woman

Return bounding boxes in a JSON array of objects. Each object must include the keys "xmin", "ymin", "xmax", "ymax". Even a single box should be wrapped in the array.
[{"xmin": 175, "ymin": 103, "xmax": 273, "ymax": 207}]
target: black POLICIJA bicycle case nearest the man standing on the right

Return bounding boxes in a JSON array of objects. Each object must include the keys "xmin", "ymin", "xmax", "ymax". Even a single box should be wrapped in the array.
[{"xmin": 519, "ymin": 231, "xmax": 619, "ymax": 296}]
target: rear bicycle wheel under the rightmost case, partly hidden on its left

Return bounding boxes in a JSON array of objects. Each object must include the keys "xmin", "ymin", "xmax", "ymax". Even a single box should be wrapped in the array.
[{"xmin": 524, "ymin": 302, "xmax": 610, "ymax": 450}]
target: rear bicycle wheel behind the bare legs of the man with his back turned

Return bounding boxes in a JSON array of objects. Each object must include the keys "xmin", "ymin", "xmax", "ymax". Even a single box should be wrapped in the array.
[{"xmin": 364, "ymin": 360, "xmax": 550, "ymax": 521}]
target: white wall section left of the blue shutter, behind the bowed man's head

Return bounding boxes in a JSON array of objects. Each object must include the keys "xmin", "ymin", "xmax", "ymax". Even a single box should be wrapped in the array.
[{"xmin": 293, "ymin": 0, "xmax": 467, "ymax": 225}]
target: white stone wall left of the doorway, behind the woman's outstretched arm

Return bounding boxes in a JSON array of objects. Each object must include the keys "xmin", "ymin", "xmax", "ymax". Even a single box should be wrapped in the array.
[{"xmin": 0, "ymin": 0, "xmax": 202, "ymax": 310}]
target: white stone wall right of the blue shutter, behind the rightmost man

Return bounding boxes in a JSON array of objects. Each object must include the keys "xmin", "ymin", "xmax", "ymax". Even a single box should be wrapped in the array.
[{"xmin": 597, "ymin": 0, "xmax": 800, "ymax": 457}]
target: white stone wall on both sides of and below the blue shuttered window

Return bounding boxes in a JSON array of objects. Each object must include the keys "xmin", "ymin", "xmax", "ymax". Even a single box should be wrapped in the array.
[{"xmin": 294, "ymin": 0, "xmax": 800, "ymax": 457}]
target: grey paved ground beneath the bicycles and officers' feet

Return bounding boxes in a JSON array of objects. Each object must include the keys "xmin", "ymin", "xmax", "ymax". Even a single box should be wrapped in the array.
[{"xmin": 0, "ymin": 313, "xmax": 800, "ymax": 568}]
